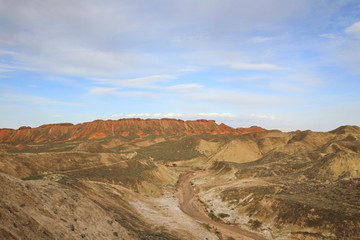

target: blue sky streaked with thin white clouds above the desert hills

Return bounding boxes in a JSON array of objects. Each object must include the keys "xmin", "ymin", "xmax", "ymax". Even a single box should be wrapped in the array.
[{"xmin": 0, "ymin": 0, "xmax": 360, "ymax": 131}]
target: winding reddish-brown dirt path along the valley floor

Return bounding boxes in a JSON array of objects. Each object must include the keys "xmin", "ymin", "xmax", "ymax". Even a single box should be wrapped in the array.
[{"xmin": 177, "ymin": 172, "xmax": 266, "ymax": 240}]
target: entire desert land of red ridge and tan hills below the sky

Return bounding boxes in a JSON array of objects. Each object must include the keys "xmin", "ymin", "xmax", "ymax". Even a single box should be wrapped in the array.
[{"xmin": 0, "ymin": 119, "xmax": 360, "ymax": 240}]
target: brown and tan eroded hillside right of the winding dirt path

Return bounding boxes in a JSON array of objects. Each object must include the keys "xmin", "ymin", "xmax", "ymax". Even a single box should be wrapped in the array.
[{"xmin": 195, "ymin": 126, "xmax": 360, "ymax": 239}]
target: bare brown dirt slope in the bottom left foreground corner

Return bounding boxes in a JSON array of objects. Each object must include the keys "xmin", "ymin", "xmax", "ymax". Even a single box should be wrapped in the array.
[{"xmin": 0, "ymin": 173, "xmax": 136, "ymax": 239}]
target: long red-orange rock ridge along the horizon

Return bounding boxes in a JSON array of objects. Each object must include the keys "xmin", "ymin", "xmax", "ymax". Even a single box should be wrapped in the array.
[{"xmin": 0, "ymin": 118, "xmax": 265, "ymax": 143}]
